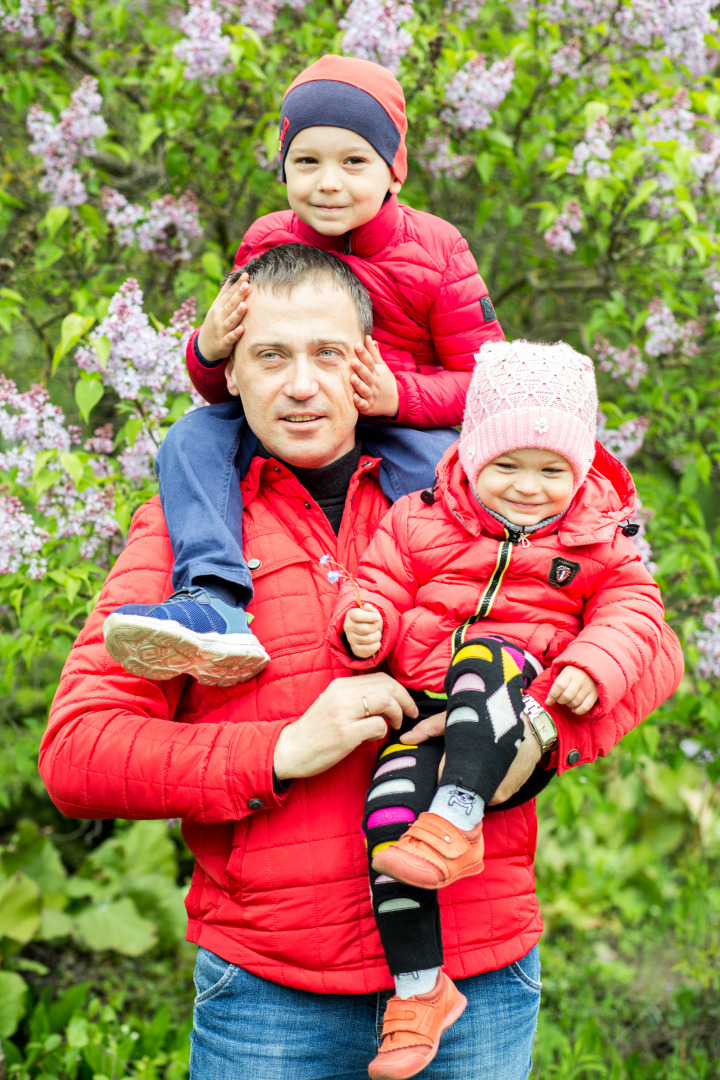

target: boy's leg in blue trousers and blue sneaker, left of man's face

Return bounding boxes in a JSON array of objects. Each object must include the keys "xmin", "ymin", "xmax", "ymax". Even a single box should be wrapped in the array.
[{"xmin": 104, "ymin": 401, "xmax": 269, "ymax": 686}]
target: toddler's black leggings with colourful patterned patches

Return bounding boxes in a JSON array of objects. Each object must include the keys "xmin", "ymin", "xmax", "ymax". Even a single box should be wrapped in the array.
[{"xmin": 363, "ymin": 635, "xmax": 544, "ymax": 975}]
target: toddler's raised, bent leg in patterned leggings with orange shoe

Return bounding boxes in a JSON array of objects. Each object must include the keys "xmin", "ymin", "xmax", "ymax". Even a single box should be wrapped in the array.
[{"xmin": 375, "ymin": 635, "xmax": 541, "ymax": 889}]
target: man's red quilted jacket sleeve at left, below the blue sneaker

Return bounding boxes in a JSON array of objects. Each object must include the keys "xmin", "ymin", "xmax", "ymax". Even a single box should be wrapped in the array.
[{"xmin": 40, "ymin": 499, "xmax": 290, "ymax": 824}]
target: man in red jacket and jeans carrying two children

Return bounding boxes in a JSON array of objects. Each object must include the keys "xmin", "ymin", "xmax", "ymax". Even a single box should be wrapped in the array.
[{"xmin": 40, "ymin": 245, "xmax": 681, "ymax": 1080}]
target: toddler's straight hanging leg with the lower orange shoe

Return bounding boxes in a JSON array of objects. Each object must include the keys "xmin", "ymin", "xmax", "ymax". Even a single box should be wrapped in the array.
[{"xmin": 363, "ymin": 708, "xmax": 467, "ymax": 1080}]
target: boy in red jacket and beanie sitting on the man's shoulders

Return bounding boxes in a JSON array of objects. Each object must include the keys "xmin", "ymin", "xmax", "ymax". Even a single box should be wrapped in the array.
[{"xmin": 105, "ymin": 56, "xmax": 503, "ymax": 686}]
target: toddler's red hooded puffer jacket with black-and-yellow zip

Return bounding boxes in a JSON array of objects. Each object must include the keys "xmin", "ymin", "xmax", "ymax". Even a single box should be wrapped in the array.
[{"xmin": 328, "ymin": 443, "xmax": 682, "ymax": 771}]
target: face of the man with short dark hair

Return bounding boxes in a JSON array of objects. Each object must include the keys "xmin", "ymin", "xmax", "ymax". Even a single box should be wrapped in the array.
[{"xmin": 226, "ymin": 281, "xmax": 363, "ymax": 469}]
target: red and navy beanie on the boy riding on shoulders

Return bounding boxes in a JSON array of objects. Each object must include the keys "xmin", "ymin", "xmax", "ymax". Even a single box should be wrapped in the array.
[{"xmin": 280, "ymin": 55, "xmax": 407, "ymax": 184}]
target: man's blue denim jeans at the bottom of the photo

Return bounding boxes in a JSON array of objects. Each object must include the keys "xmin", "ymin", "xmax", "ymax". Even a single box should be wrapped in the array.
[{"xmin": 190, "ymin": 945, "xmax": 541, "ymax": 1080}]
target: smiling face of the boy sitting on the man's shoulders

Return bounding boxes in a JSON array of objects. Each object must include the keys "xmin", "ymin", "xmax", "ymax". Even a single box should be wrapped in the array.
[{"xmin": 285, "ymin": 127, "xmax": 402, "ymax": 237}]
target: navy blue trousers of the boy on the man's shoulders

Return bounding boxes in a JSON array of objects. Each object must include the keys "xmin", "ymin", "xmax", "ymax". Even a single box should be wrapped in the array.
[{"xmin": 155, "ymin": 400, "xmax": 458, "ymax": 599}]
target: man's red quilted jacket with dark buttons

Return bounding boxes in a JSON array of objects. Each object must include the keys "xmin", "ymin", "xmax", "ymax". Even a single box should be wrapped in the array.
[{"xmin": 40, "ymin": 457, "xmax": 677, "ymax": 994}]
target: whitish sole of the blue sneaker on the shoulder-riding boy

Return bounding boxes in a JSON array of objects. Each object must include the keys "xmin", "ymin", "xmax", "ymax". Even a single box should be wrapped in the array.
[{"xmin": 103, "ymin": 612, "xmax": 270, "ymax": 686}]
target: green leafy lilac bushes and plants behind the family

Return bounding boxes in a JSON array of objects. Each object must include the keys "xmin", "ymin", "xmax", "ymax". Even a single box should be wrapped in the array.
[{"xmin": 0, "ymin": 0, "xmax": 720, "ymax": 1080}]
